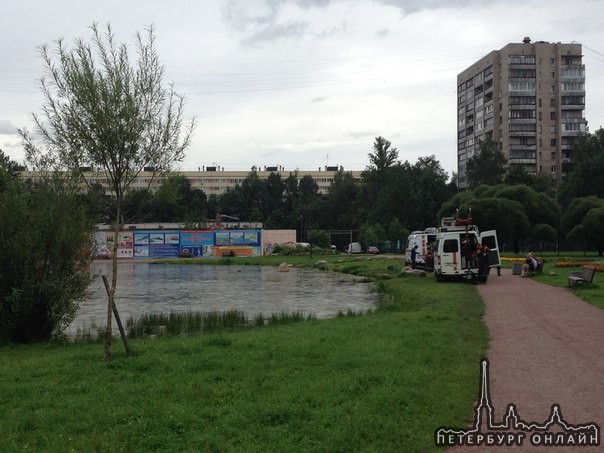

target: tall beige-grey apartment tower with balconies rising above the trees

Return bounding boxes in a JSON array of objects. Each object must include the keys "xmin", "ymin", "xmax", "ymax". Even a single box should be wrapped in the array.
[{"xmin": 457, "ymin": 38, "xmax": 587, "ymax": 189}]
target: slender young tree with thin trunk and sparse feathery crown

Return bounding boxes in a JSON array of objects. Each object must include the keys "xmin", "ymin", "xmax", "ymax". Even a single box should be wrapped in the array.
[{"xmin": 20, "ymin": 24, "xmax": 195, "ymax": 360}]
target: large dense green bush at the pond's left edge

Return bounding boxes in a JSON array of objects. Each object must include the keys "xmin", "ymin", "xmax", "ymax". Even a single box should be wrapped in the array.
[{"xmin": 0, "ymin": 177, "xmax": 92, "ymax": 343}]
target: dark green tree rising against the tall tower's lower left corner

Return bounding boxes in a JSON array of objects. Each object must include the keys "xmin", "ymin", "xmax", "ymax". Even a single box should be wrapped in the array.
[{"xmin": 466, "ymin": 139, "xmax": 506, "ymax": 188}]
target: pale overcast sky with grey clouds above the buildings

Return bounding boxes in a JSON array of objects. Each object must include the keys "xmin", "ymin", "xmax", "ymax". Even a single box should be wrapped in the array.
[{"xmin": 0, "ymin": 0, "xmax": 604, "ymax": 177}]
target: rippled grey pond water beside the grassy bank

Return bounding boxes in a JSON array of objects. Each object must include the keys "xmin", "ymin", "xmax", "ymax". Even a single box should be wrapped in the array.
[{"xmin": 67, "ymin": 262, "xmax": 379, "ymax": 333}]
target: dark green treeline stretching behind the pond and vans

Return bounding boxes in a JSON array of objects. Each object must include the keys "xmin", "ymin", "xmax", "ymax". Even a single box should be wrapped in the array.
[{"xmin": 80, "ymin": 129, "xmax": 604, "ymax": 253}]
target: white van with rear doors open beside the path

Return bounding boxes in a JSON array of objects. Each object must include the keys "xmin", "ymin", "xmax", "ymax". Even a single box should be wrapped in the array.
[{"xmin": 434, "ymin": 217, "xmax": 501, "ymax": 282}]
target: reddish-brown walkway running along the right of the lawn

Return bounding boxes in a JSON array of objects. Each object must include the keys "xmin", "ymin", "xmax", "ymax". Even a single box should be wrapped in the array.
[{"xmin": 450, "ymin": 269, "xmax": 604, "ymax": 452}]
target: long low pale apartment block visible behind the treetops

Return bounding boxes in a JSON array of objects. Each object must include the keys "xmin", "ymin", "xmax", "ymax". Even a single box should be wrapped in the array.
[{"xmin": 21, "ymin": 167, "xmax": 362, "ymax": 195}]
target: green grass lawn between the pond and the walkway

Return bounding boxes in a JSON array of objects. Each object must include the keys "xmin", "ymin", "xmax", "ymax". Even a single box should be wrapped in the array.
[{"xmin": 0, "ymin": 256, "xmax": 488, "ymax": 452}]
